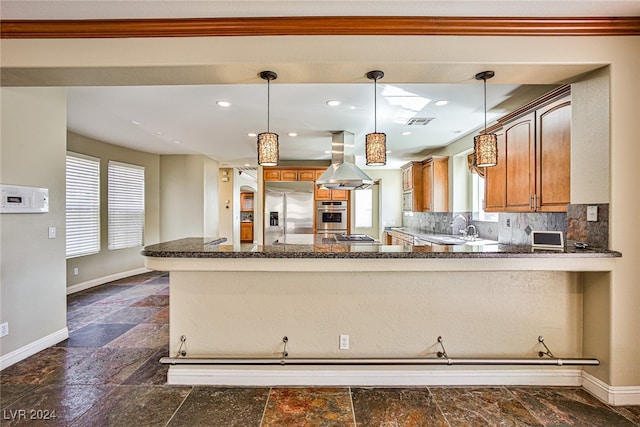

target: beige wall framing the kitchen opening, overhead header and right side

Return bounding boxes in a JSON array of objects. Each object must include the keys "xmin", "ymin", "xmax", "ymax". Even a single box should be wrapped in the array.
[{"xmin": 0, "ymin": 36, "xmax": 640, "ymax": 386}]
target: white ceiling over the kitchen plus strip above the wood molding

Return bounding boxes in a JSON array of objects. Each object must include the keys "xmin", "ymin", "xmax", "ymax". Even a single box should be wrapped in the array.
[{"xmin": 0, "ymin": 0, "xmax": 640, "ymax": 168}]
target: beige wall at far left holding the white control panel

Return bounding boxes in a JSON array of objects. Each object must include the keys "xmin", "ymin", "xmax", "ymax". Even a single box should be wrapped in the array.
[{"xmin": 0, "ymin": 88, "xmax": 67, "ymax": 360}]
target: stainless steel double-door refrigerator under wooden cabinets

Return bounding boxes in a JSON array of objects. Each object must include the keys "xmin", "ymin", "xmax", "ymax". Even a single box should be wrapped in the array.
[{"xmin": 264, "ymin": 181, "xmax": 314, "ymax": 245}]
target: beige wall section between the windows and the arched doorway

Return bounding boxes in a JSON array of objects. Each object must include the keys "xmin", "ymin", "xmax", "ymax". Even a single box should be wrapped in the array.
[{"xmin": 160, "ymin": 155, "xmax": 218, "ymax": 241}]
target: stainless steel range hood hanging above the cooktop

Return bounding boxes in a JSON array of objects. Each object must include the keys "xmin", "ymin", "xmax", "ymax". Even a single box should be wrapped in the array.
[{"xmin": 316, "ymin": 131, "xmax": 373, "ymax": 190}]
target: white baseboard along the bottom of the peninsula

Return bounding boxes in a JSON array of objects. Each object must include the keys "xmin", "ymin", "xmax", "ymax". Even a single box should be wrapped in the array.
[{"xmin": 167, "ymin": 365, "xmax": 582, "ymax": 387}]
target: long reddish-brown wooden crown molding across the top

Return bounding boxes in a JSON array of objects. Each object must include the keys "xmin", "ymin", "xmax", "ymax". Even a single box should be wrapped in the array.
[{"xmin": 0, "ymin": 16, "xmax": 640, "ymax": 39}]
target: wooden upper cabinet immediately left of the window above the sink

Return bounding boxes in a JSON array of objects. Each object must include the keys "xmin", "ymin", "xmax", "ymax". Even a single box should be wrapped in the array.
[{"xmin": 422, "ymin": 157, "xmax": 449, "ymax": 212}]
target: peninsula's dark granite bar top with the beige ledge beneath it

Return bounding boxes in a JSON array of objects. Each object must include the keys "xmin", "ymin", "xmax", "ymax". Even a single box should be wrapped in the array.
[{"xmin": 141, "ymin": 237, "xmax": 622, "ymax": 271}]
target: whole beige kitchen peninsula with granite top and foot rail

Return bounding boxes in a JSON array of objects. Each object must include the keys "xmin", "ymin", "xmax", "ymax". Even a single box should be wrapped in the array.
[{"xmin": 142, "ymin": 238, "xmax": 621, "ymax": 385}]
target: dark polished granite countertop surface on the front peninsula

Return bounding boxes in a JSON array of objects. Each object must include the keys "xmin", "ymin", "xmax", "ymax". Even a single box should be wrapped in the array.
[{"xmin": 141, "ymin": 236, "xmax": 622, "ymax": 259}]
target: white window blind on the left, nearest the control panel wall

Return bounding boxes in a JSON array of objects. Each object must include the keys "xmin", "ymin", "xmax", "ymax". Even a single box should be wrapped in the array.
[{"xmin": 65, "ymin": 153, "xmax": 100, "ymax": 258}]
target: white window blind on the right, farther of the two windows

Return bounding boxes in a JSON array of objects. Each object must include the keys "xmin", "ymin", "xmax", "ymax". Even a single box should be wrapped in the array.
[{"xmin": 108, "ymin": 161, "xmax": 144, "ymax": 250}]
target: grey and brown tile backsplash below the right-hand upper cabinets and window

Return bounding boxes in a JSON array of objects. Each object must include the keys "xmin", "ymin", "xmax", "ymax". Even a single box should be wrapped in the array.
[{"xmin": 402, "ymin": 204, "xmax": 609, "ymax": 248}]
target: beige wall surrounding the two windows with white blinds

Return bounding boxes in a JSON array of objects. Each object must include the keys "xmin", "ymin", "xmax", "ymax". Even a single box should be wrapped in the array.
[{"xmin": 66, "ymin": 132, "xmax": 160, "ymax": 288}]
